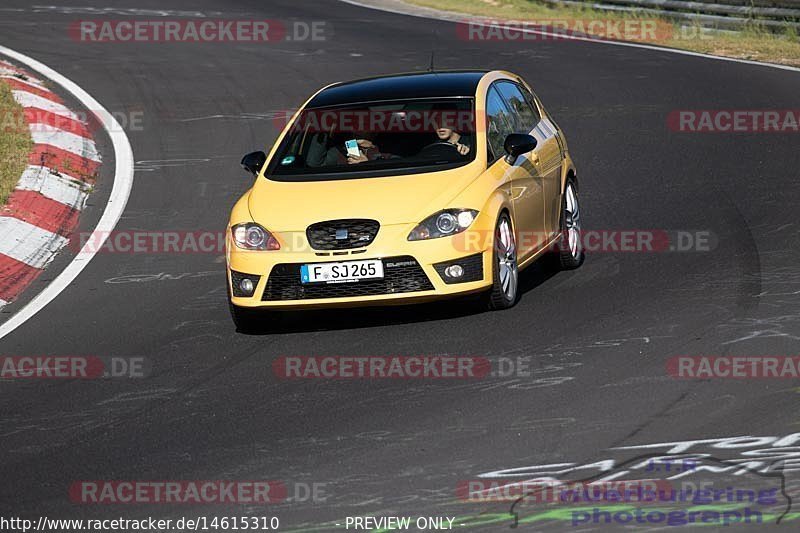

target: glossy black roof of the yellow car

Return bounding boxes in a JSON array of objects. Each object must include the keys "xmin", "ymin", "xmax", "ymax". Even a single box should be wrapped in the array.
[{"xmin": 306, "ymin": 70, "xmax": 489, "ymax": 108}]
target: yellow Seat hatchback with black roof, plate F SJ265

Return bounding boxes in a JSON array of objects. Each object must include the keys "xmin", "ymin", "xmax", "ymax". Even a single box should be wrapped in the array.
[{"xmin": 226, "ymin": 71, "xmax": 584, "ymax": 329}]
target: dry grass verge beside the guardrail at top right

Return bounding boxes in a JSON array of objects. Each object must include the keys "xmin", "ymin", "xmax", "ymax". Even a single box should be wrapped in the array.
[{"xmin": 405, "ymin": 0, "xmax": 800, "ymax": 66}]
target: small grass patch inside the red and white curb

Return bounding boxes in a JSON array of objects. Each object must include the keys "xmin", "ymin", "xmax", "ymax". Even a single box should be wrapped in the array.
[{"xmin": 0, "ymin": 80, "xmax": 33, "ymax": 206}]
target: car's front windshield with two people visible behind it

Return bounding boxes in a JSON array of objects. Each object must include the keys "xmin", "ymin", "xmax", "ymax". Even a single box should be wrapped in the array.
[{"xmin": 266, "ymin": 98, "xmax": 475, "ymax": 181}]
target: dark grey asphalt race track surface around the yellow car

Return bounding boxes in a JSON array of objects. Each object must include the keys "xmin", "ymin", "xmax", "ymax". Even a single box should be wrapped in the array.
[{"xmin": 0, "ymin": 0, "xmax": 800, "ymax": 531}]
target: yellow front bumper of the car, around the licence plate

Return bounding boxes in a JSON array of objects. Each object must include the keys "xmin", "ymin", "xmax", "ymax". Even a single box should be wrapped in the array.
[{"xmin": 226, "ymin": 224, "xmax": 492, "ymax": 308}]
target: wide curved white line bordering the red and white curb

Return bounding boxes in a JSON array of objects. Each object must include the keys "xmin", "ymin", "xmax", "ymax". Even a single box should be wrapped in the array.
[{"xmin": 0, "ymin": 46, "xmax": 133, "ymax": 339}]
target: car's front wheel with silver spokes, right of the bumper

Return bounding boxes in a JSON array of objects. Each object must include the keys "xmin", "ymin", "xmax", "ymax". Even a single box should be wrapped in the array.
[{"xmin": 487, "ymin": 213, "xmax": 519, "ymax": 309}]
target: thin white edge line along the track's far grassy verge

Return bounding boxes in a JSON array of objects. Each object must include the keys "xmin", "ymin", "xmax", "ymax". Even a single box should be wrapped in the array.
[{"xmin": 339, "ymin": 0, "xmax": 800, "ymax": 72}]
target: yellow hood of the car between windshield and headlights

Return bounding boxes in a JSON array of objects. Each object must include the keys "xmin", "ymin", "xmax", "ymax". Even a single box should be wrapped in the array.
[{"xmin": 248, "ymin": 164, "xmax": 479, "ymax": 231}]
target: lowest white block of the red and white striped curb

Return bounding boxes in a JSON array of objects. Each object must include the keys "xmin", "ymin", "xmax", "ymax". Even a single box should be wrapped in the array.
[{"xmin": 0, "ymin": 217, "xmax": 69, "ymax": 268}]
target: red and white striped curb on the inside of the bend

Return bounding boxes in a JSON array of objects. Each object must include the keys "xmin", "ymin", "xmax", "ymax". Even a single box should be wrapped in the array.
[{"xmin": 0, "ymin": 60, "xmax": 101, "ymax": 308}]
